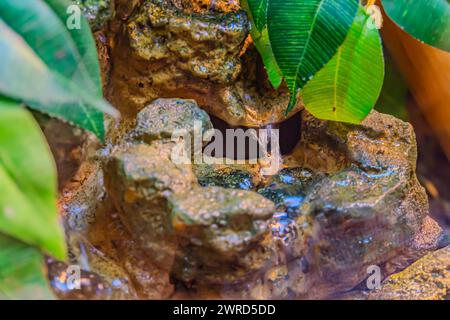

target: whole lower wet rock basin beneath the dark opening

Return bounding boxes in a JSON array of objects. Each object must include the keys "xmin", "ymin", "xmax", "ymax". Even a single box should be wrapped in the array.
[{"xmin": 55, "ymin": 94, "xmax": 441, "ymax": 299}]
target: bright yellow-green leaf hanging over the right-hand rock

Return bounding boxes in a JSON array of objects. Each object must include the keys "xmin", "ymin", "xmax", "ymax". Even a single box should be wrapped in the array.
[{"xmin": 302, "ymin": 8, "xmax": 384, "ymax": 123}]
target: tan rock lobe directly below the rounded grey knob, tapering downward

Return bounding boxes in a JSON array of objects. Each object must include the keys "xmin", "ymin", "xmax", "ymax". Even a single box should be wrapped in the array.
[{"xmin": 104, "ymin": 143, "xmax": 195, "ymax": 267}]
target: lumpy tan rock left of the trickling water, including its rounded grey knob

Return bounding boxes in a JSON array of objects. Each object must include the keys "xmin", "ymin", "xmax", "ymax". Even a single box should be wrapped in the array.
[{"xmin": 104, "ymin": 99, "xmax": 275, "ymax": 284}]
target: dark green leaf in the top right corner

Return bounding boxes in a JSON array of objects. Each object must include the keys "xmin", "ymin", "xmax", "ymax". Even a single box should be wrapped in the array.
[{"xmin": 383, "ymin": 0, "xmax": 450, "ymax": 51}]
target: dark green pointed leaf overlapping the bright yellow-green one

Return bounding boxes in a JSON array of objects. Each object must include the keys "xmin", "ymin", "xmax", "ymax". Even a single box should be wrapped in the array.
[{"xmin": 267, "ymin": 0, "xmax": 358, "ymax": 112}]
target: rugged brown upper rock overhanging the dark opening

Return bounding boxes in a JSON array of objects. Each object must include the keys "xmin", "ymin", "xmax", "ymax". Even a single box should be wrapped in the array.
[{"xmin": 108, "ymin": 0, "xmax": 302, "ymax": 127}]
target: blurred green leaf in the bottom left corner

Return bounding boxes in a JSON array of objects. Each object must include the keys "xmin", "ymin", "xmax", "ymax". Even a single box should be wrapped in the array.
[{"xmin": 0, "ymin": 234, "xmax": 54, "ymax": 300}]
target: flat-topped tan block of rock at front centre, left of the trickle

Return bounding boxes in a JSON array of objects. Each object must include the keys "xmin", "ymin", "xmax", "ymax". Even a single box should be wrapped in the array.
[{"xmin": 169, "ymin": 187, "xmax": 275, "ymax": 285}]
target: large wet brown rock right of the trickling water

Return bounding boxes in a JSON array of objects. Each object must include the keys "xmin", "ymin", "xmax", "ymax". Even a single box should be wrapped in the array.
[{"xmin": 244, "ymin": 112, "xmax": 440, "ymax": 298}]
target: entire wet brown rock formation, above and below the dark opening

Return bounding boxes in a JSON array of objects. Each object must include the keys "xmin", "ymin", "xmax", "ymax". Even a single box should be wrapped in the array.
[{"xmin": 55, "ymin": 0, "xmax": 441, "ymax": 299}]
